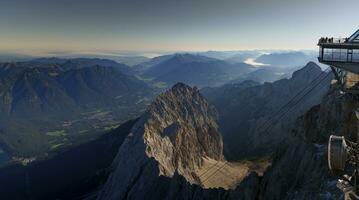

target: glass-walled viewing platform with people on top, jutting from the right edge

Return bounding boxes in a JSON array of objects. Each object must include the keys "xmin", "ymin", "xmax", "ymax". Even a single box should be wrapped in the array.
[{"xmin": 318, "ymin": 30, "xmax": 359, "ymax": 93}]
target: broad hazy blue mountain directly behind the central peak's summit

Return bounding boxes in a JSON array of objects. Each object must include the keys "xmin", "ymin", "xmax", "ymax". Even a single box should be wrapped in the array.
[{"xmin": 142, "ymin": 54, "xmax": 253, "ymax": 87}]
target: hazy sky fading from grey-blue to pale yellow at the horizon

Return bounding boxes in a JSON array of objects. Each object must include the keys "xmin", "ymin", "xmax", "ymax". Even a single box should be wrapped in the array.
[{"xmin": 0, "ymin": 0, "xmax": 359, "ymax": 52}]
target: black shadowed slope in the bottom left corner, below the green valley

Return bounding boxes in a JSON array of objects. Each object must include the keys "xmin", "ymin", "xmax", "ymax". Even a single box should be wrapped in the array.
[{"xmin": 0, "ymin": 120, "xmax": 136, "ymax": 199}]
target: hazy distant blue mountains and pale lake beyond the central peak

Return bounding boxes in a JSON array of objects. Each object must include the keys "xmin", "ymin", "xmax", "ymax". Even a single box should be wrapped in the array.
[{"xmin": 132, "ymin": 51, "xmax": 316, "ymax": 87}]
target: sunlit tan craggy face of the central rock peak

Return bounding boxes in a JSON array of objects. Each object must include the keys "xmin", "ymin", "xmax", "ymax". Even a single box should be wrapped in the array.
[{"xmin": 144, "ymin": 83, "xmax": 223, "ymax": 178}]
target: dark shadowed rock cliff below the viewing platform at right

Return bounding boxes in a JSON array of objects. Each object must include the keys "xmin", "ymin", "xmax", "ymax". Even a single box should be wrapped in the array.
[{"xmin": 260, "ymin": 82, "xmax": 359, "ymax": 200}]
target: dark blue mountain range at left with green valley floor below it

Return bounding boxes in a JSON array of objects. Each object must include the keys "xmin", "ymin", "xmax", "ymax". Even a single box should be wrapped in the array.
[{"xmin": 0, "ymin": 58, "xmax": 153, "ymax": 156}]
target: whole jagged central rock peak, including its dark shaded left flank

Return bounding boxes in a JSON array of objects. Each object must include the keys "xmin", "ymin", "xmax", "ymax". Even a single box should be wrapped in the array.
[{"xmin": 99, "ymin": 83, "xmax": 223, "ymax": 199}]
